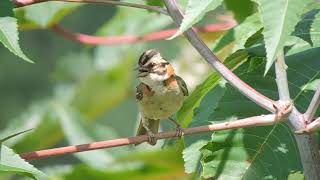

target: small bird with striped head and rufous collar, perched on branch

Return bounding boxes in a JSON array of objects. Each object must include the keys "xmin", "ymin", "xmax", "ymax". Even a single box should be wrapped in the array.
[{"xmin": 136, "ymin": 49, "xmax": 189, "ymax": 145}]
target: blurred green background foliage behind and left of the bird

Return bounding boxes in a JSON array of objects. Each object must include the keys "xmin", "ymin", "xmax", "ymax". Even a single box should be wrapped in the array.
[{"xmin": 0, "ymin": 3, "xmax": 223, "ymax": 179}]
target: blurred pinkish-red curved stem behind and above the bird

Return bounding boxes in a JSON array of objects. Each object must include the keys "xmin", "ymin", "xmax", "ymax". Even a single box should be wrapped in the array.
[{"xmin": 52, "ymin": 16, "xmax": 236, "ymax": 45}]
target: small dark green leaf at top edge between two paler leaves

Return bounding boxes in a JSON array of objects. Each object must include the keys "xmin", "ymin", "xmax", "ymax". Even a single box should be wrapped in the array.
[{"xmin": 224, "ymin": 0, "xmax": 255, "ymax": 23}]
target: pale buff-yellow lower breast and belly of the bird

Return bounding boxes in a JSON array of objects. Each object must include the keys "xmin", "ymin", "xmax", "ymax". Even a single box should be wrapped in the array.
[{"xmin": 139, "ymin": 88, "xmax": 184, "ymax": 119}]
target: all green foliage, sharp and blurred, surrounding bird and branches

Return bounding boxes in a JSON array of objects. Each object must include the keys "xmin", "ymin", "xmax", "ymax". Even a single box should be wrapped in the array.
[{"xmin": 0, "ymin": 0, "xmax": 320, "ymax": 179}]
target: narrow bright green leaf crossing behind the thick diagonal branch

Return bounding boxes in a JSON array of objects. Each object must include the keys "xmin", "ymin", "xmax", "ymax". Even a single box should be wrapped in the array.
[{"xmin": 177, "ymin": 50, "xmax": 248, "ymax": 127}]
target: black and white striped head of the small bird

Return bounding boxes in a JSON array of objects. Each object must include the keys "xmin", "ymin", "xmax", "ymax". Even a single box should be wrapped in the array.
[{"xmin": 138, "ymin": 49, "xmax": 174, "ymax": 85}]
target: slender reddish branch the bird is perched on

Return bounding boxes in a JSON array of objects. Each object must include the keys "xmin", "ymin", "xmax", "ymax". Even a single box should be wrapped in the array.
[{"xmin": 20, "ymin": 112, "xmax": 288, "ymax": 160}]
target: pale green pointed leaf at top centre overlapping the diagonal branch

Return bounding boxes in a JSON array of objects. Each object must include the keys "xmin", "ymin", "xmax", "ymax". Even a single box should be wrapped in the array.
[{"xmin": 169, "ymin": 0, "xmax": 222, "ymax": 39}]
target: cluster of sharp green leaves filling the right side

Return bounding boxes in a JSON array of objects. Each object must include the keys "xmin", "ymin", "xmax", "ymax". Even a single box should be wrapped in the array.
[{"xmin": 173, "ymin": 0, "xmax": 320, "ymax": 179}]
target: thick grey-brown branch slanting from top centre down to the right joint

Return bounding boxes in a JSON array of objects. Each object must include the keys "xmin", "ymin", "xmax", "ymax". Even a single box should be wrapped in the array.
[{"xmin": 164, "ymin": 0, "xmax": 280, "ymax": 112}]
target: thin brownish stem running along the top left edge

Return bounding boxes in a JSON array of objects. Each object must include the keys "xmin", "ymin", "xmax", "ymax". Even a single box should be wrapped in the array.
[{"xmin": 14, "ymin": 0, "xmax": 168, "ymax": 15}]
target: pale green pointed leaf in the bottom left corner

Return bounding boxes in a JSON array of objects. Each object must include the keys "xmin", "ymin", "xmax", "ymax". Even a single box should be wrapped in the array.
[{"xmin": 0, "ymin": 145, "xmax": 46, "ymax": 179}]
